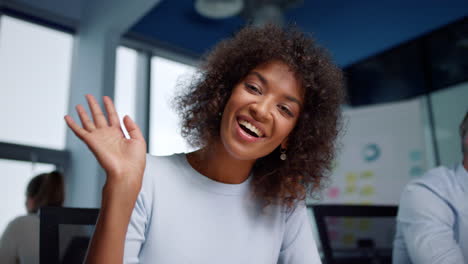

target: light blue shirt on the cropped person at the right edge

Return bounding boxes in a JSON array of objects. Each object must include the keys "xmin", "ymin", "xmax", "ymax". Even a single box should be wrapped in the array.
[{"xmin": 393, "ymin": 164, "xmax": 468, "ymax": 264}]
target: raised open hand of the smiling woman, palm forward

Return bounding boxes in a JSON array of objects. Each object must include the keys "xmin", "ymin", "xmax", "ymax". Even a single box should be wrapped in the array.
[{"xmin": 65, "ymin": 95, "xmax": 146, "ymax": 191}]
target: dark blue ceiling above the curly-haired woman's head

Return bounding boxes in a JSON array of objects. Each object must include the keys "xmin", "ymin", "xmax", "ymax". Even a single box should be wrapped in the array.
[{"xmin": 130, "ymin": 0, "xmax": 468, "ymax": 66}]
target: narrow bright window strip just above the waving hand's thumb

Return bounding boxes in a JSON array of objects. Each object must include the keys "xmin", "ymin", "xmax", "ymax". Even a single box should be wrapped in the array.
[{"xmin": 115, "ymin": 46, "xmax": 138, "ymax": 137}]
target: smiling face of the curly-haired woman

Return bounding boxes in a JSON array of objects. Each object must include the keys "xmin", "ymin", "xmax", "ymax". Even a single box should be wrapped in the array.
[{"xmin": 220, "ymin": 61, "xmax": 303, "ymax": 160}]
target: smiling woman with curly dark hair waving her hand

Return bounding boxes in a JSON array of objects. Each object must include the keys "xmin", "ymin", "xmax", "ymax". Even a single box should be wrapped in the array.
[{"xmin": 65, "ymin": 25, "xmax": 343, "ymax": 263}]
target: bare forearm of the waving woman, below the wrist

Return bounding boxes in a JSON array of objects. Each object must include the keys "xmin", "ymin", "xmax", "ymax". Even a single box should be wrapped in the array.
[{"xmin": 85, "ymin": 177, "xmax": 139, "ymax": 264}]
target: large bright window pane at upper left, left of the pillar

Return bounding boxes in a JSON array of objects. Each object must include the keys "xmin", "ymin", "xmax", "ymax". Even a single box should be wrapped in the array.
[{"xmin": 0, "ymin": 16, "xmax": 73, "ymax": 149}]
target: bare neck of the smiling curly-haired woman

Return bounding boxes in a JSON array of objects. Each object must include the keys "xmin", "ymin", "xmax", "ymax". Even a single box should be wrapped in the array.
[{"xmin": 187, "ymin": 143, "xmax": 255, "ymax": 184}]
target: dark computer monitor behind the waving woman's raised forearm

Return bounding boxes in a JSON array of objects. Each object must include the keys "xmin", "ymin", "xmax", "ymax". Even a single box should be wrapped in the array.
[{"xmin": 39, "ymin": 207, "xmax": 99, "ymax": 264}]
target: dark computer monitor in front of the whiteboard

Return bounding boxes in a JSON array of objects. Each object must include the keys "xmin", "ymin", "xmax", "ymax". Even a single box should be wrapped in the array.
[{"xmin": 310, "ymin": 205, "xmax": 398, "ymax": 264}]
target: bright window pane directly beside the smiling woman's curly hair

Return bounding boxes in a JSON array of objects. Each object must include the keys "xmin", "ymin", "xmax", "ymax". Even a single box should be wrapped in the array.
[{"xmin": 149, "ymin": 56, "xmax": 196, "ymax": 156}]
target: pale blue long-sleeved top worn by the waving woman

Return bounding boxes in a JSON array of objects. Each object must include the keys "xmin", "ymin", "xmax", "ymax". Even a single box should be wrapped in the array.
[{"xmin": 124, "ymin": 155, "xmax": 321, "ymax": 264}]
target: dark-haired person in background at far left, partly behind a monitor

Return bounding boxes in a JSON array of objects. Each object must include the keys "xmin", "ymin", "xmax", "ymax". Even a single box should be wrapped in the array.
[{"xmin": 0, "ymin": 171, "xmax": 65, "ymax": 264}]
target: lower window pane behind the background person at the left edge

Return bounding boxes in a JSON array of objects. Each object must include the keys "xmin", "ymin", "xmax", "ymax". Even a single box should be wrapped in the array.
[{"xmin": 0, "ymin": 159, "xmax": 55, "ymax": 235}]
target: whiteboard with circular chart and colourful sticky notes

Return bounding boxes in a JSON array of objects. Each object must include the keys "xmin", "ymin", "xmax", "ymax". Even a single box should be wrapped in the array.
[{"xmin": 314, "ymin": 99, "xmax": 427, "ymax": 205}]
